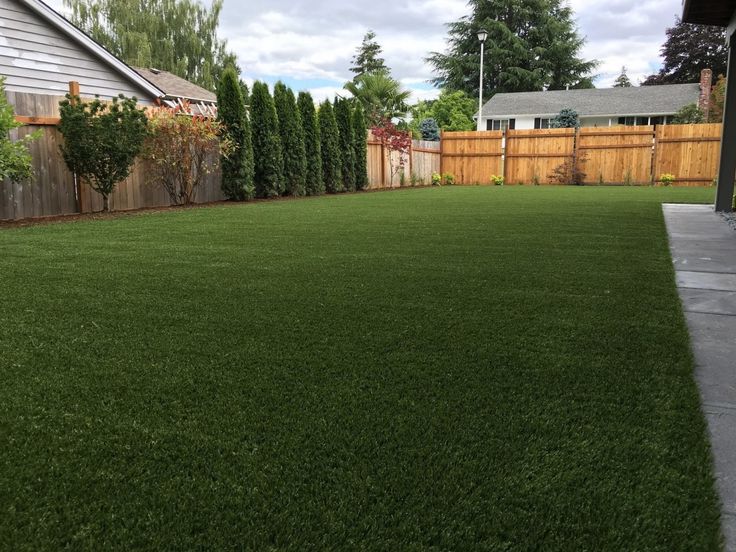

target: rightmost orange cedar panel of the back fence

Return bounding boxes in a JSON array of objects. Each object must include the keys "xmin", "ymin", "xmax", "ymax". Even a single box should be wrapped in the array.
[{"xmin": 654, "ymin": 123, "xmax": 722, "ymax": 186}]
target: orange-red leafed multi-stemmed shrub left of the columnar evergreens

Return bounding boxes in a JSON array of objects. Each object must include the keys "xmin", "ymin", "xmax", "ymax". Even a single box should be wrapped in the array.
[{"xmin": 144, "ymin": 105, "xmax": 230, "ymax": 205}]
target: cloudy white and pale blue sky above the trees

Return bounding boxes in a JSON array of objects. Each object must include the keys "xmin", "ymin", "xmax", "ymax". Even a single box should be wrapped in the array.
[{"xmin": 49, "ymin": 0, "xmax": 682, "ymax": 101}]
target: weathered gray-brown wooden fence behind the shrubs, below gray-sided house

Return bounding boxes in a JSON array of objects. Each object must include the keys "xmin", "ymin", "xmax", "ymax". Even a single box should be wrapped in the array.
[{"xmin": 0, "ymin": 88, "xmax": 224, "ymax": 220}]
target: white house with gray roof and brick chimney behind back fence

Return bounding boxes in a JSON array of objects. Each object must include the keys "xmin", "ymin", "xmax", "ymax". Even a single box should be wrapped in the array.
[{"xmin": 475, "ymin": 69, "xmax": 712, "ymax": 130}]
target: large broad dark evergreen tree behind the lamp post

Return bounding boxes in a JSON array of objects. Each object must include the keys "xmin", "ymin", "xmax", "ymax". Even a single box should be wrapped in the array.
[{"xmin": 427, "ymin": 0, "xmax": 597, "ymax": 97}]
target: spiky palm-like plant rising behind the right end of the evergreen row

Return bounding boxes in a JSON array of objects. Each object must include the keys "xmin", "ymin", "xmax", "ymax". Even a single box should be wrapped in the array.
[{"xmin": 345, "ymin": 72, "xmax": 411, "ymax": 123}]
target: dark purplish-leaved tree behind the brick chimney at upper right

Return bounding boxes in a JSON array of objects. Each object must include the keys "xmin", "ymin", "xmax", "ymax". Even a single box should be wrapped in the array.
[{"xmin": 642, "ymin": 17, "xmax": 728, "ymax": 86}]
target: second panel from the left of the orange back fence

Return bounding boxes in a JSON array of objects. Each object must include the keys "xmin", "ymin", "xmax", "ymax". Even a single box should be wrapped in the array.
[{"xmin": 504, "ymin": 128, "xmax": 575, "ymax": 184}]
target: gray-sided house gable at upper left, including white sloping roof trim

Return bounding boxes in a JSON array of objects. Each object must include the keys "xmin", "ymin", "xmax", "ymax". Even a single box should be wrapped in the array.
[{"xmin": 0, "ymin": 0, "xmax": 164, "ymax": 105}]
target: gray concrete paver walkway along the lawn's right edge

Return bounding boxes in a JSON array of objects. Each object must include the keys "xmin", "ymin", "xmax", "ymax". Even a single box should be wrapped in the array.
[{"xmin": 663, "ymin": 204, "xmax": 736, "ymax": 552}]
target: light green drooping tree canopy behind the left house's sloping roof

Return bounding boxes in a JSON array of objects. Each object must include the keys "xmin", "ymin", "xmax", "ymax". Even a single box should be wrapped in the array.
[{"xmin": 64, "ymin": 0, "xmax": 237, "ymax": 90}]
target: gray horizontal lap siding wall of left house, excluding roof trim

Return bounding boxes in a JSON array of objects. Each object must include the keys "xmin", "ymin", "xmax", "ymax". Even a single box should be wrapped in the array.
[{"xmin": 0, "ymin": 0, "xmax": 152, "ymax": 104}]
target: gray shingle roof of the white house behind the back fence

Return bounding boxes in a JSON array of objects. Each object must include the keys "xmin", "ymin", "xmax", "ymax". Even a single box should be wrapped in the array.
[{"xmin": 476, "ymin": 84, "xmax": 700, "ymax": 118}]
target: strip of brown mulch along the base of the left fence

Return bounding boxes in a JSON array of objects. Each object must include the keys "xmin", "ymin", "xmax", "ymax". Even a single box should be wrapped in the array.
[{"xmin": 0, "ymin": 185, "xmax": 436, "ymax": 230}]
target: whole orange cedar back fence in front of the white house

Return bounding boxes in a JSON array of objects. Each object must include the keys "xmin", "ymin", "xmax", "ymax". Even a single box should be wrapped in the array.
[{"xmin": 441, "ymin": 124, "xmax": 721, "ymax": 186}]
